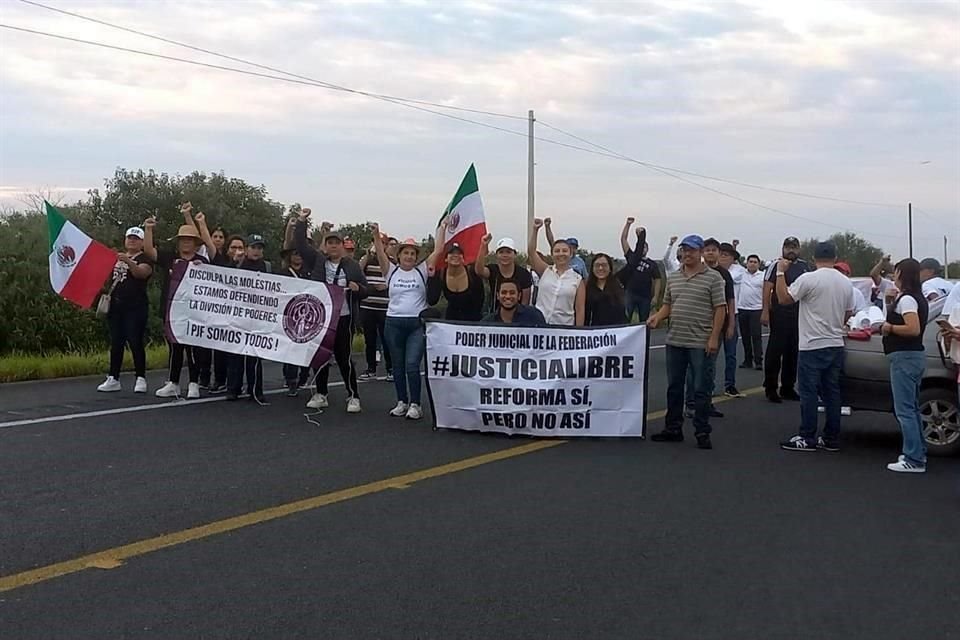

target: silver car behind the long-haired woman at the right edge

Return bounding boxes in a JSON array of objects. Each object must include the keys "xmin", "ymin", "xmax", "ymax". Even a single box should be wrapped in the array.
[{"xmin": 840, "ymin": 298, "xmax": 960, "ymax": 456}]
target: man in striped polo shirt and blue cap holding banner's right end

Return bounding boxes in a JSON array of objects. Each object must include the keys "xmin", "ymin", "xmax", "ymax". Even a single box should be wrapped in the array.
[{"xmin": 647, "ymin": 235, "xmax": 727, "ymax": 449}]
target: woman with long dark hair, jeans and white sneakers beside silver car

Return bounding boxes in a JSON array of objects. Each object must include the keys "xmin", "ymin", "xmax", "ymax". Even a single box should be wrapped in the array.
[{"xmin": 882, "ymin": 258, "xmax": 928, "ymax": 473}]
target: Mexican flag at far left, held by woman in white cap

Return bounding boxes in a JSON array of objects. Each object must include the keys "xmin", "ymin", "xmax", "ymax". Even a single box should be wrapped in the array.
[{"xmin": 43, "ymin": 200, "xmax": 117, "ymax": 308}]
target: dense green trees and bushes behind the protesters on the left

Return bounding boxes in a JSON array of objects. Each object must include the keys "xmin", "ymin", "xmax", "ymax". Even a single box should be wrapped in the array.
[{"xmin": 0, "ymin": 169, "xmax": 284, "ymax": 353}]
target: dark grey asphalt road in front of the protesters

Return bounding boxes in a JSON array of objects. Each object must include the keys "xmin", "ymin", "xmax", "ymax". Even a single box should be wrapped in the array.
[{"xmin": 0, "ymin": 338, "xmax": 960, "ymax": 639}]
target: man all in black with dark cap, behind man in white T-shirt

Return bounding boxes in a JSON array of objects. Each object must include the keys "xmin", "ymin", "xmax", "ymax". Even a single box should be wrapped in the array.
[{"xmin": 760, "ymin": 236, "xmax": 810, "ymax": 403}]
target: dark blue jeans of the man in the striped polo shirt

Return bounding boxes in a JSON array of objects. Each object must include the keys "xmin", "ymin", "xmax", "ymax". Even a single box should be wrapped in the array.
[{"xmin": 665, "ymin": 344, "xmax": 715, "ymax": 435}]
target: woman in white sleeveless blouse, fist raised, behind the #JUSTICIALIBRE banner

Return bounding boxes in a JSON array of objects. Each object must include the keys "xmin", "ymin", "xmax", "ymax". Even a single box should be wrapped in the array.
[{"xmin": 527, "ymin": 218, "xmax": 586, "ymax": 327}]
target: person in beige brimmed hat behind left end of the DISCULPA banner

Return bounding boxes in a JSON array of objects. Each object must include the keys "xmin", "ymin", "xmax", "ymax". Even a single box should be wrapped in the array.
[{"xmin": 143, "ymin": 202, "xmax": 217, "ymax": 399}]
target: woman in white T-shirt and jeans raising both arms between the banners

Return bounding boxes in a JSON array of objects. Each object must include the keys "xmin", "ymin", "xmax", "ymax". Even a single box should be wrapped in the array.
[{"xmin": 373, "ymin": 221, "xmax": 446, "ymax": 420}]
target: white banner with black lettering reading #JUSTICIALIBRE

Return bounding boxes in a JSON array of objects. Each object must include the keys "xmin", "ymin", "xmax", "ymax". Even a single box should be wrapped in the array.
[{"xmin": 426, "ymin": 321, "xmax": 648, "ymax": 438}]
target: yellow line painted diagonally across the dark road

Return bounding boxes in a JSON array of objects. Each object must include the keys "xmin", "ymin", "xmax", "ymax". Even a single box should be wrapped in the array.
[{"xmin": 0, "ymin": 387, "xmax": 762, "ymax": 593}]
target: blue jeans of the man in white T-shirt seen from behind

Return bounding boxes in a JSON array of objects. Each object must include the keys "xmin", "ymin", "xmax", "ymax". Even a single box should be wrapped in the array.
[{"xmin": 797, "ymin": 347, "xmax": 843, "ymax": 445}]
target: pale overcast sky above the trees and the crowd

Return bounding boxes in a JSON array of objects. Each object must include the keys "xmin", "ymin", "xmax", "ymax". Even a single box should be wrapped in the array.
[{"xmin": 0, "ymin": 0, "xmax": 960, "ymax": 258}]
